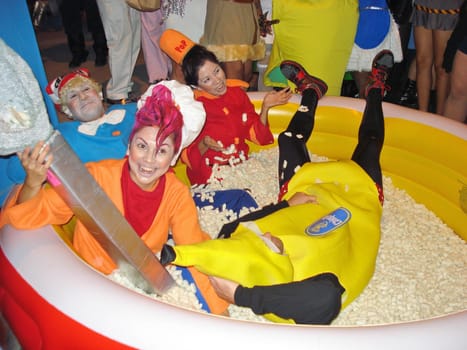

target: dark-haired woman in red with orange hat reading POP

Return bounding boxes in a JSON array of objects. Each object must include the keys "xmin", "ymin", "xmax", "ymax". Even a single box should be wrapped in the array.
[{"xmin": 160, "ymin": 29, "xmax": 291, "ymax": 185}]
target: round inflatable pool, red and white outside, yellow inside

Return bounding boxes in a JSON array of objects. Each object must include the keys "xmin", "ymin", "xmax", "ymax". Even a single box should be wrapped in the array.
[{"xmin": 0, "ymin": 93, "xmax": 467, "ymax": 350}]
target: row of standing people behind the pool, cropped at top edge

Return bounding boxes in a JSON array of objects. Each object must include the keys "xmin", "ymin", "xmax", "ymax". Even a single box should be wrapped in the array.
[{"xmin": 29, "ymin": 0, "xmax": 467, "ymax": 121}]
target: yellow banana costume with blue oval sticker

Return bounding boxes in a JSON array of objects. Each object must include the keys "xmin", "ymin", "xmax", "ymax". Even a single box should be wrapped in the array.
[{"xmin": 165, "ymin": 161, "xmax": 382, "ymax": 322}]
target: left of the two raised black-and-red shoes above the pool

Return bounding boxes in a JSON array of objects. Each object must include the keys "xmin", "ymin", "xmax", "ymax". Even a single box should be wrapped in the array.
[{"xmin": 280, "ymin": 61, "xmax": 328, "ymax": 98}]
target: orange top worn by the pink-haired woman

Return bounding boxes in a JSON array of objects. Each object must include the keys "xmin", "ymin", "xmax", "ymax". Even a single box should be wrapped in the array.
[{"xmin": 0, "ymin": 159, "xmax": 228, "ymax": 314}]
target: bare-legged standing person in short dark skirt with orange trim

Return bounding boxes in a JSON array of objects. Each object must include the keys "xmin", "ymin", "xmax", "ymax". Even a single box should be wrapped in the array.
[{"xmin": 412, "ymin": 0, "xmax": 463, "ymax": 114}]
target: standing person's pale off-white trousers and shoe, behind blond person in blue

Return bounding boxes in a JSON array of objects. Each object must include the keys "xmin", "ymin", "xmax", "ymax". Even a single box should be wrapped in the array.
[{"xmin": 97, "ymin": 0, "xmax": 141, "ymax": 104}]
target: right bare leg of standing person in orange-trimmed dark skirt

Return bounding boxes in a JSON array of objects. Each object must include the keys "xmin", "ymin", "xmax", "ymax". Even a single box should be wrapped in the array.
[{"xmin": 433, "ymin": 30, "xmax": 452, "ymax": 114}]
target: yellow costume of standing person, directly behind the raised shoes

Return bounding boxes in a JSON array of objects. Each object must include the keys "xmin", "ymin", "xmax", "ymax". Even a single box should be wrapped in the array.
[{"xmin": 264, "ymin": 0, "xmax": 359, "ymax": 96}]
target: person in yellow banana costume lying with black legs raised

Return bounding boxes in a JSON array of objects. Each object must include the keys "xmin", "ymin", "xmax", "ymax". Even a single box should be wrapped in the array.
[{"xmin": 161, "ymin": 51, "xmax": 394, "ymax": 324}]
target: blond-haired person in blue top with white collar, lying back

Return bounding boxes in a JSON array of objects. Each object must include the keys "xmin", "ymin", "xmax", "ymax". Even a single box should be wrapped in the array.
[{"xmin": 0, "ymin": 68, "xmax": 136, "ymax": 207}]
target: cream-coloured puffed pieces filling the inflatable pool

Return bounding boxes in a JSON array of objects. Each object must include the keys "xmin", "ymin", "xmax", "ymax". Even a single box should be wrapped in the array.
[{"xmin": 112, "ymin": 148, "xmax": 467, "ymax": 326}]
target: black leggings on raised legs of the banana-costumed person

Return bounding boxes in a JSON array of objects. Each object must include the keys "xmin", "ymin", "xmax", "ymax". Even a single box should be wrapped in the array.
[{"xmin": 278, "ymin": 89, "xmax": 384, "ymax": 188}]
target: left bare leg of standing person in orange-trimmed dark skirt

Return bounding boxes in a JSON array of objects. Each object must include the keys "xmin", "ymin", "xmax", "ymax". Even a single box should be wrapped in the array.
[{"xmin": 414, "ymin": 26, "xmax": 434, "ymax": 112}]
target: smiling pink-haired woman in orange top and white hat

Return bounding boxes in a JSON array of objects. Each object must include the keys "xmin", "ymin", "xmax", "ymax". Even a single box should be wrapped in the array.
[{"xmin": 0, "ymin": 81, "xmax": 228, "ymax": 314}]
